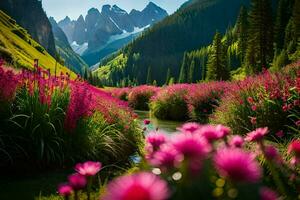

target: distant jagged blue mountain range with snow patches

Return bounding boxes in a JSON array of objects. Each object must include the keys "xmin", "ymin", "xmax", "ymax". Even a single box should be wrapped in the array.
[{"xmin": 58, "ymin": 2, "xmax": 168, "ymax": 66}]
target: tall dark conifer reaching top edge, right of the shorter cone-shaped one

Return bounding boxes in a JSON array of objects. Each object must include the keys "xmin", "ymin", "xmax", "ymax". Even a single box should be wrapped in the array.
[{"xmin": 247, "ymin": 0, "xmax": 273, "ymax": 73}]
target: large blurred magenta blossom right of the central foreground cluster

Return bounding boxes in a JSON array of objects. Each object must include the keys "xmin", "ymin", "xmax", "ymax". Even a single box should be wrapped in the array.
[{"xmin": 214, "ymin": 148, "xmax": 261, "ymax": 183}]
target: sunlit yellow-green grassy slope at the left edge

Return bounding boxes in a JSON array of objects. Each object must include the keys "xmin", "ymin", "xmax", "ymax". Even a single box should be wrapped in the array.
[{"xmin": 0, "ymin": 10, "xmax": 75, "ymax": 77}]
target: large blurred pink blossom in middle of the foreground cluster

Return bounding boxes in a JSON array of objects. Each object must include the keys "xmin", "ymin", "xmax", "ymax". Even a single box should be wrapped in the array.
[{"xmin": 173, "ymin": 134, "xmax": 211, "ymax": 159}]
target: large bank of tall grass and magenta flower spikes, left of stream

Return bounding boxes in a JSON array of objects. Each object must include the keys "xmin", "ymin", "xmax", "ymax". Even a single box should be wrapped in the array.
[{"xmin": 0, "ymin": 63, "xmax": 142, "ymax": 170}]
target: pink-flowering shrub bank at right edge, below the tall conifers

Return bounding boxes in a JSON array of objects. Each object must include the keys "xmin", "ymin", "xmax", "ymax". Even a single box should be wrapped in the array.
[{"xmin": 211, "ymin": 64, "xmax": 300, "ymax": 139}]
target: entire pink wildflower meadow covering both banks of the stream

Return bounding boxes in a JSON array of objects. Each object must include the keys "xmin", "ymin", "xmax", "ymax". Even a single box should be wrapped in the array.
[{"xmin": 0, "ymin": 63, "xmax": 300, "ymax": 200}]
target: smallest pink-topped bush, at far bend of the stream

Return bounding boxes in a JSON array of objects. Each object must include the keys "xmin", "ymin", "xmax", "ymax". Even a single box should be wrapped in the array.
[{"xmin": 128, "ymin": 85, "xmax": 159, "ymax": 110}]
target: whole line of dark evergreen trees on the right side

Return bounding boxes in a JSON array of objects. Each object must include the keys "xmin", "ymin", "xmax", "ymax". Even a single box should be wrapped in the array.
[{"xmin": 178, "ymin": 0, "xmax": 300, "ymax": 83}]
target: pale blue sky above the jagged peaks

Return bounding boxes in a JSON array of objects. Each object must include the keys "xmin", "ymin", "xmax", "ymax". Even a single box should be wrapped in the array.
[{"xmin": 42, "ymin": 0, "xmax": 186, "ymax": 20}]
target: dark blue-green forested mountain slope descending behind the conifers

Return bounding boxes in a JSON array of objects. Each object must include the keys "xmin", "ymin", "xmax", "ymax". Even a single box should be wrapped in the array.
[{"xmin": 95, "ymin": 0, "xmax": 250, "ymax": 84}]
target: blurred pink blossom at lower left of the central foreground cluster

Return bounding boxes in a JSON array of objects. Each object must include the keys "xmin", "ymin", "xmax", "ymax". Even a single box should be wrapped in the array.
[{"xmin": 151, "ymin": 144, "xmax": 183, "ymax": 169}]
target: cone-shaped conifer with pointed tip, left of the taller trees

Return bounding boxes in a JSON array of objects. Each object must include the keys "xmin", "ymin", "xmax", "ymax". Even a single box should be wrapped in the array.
[{"xmin": 206, "ymin": 32, "xmax": 229, "ymax": 80}]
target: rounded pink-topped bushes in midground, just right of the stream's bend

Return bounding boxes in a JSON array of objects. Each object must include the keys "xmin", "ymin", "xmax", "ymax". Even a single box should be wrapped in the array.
[{"xmin": 151, "ymin": 82, "xmax": 229, "ymax": 123}]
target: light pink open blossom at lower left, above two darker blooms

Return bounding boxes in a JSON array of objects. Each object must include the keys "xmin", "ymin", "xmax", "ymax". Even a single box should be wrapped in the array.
[{"xmin": 75, "ymin": 161, "xmax": 102, "ymax": 176}]
